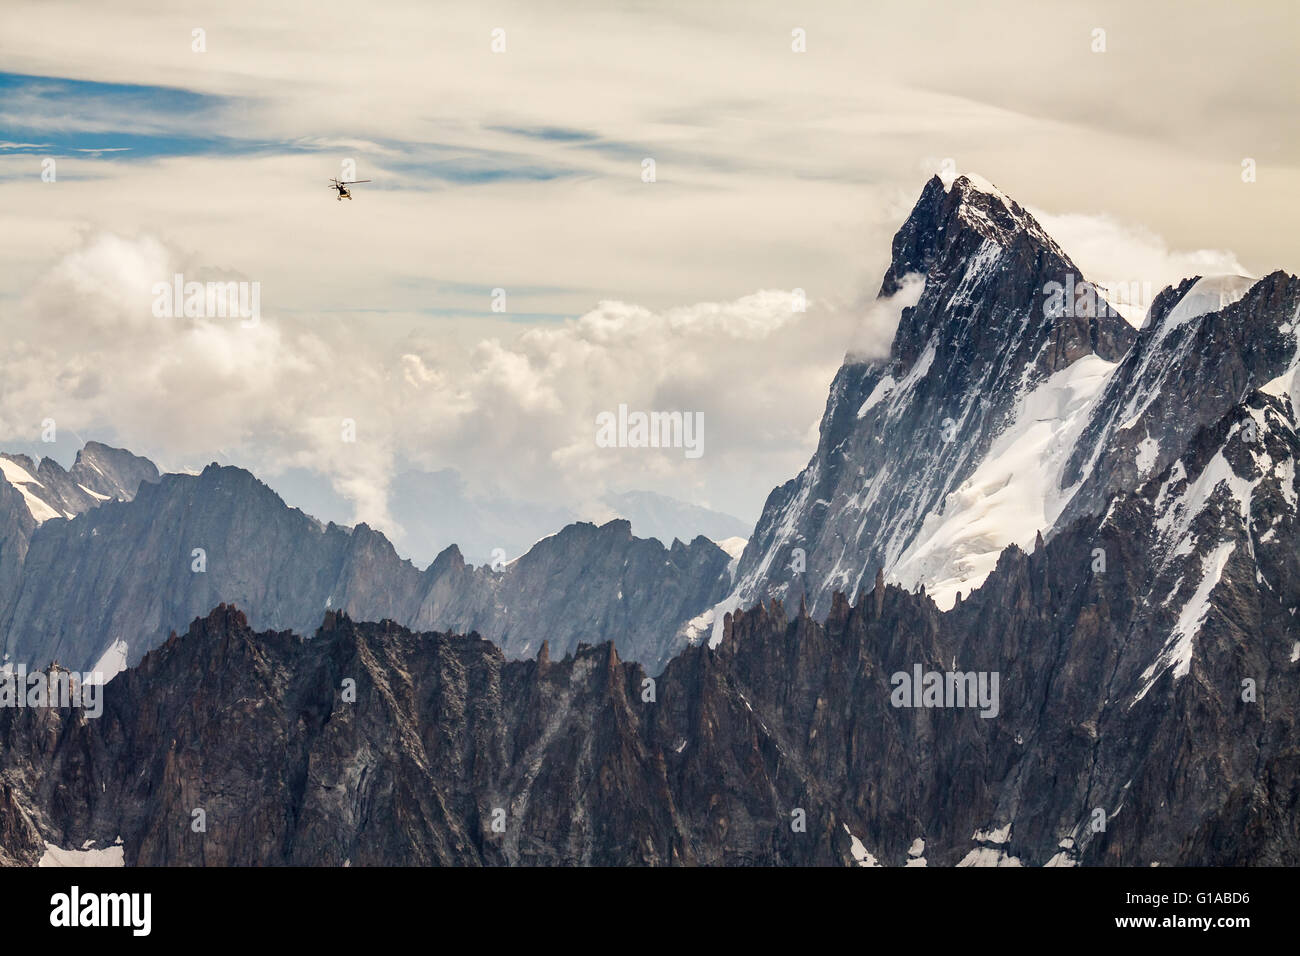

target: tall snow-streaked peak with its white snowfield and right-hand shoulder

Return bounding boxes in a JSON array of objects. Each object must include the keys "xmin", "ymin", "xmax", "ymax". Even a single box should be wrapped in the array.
[{"xmin": 712, "ymin": 177, "xmax": 1296, "ymax": 637}]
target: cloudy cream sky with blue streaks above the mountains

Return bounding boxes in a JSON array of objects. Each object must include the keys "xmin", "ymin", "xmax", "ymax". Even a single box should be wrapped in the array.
[{"xmin": 0, "ymin": 0, "xmax": 1300, "ymax": 548}]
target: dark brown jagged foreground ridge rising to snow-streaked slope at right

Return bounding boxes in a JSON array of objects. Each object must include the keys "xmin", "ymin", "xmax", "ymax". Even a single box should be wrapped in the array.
[{"xmin": 0, "ymin": 421, "xmax": 1300, "ymax": 866}]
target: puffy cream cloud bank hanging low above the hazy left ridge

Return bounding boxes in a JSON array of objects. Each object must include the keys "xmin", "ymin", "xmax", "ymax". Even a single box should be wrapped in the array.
[{"xmin": 0, "ymin": 234, "xmax": 857, "ymax": 532}]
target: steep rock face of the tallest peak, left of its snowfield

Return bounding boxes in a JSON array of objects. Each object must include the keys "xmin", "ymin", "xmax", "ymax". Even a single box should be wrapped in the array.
[{"xmin": 719, "ymin": 177, "xmax": 1135, "ymax": 629}]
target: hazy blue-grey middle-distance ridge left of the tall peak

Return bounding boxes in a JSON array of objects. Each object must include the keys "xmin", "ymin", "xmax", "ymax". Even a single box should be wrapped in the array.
[{"xmin": 0, "ymin": 464, "xmax": 731, "ymax": 672}]
